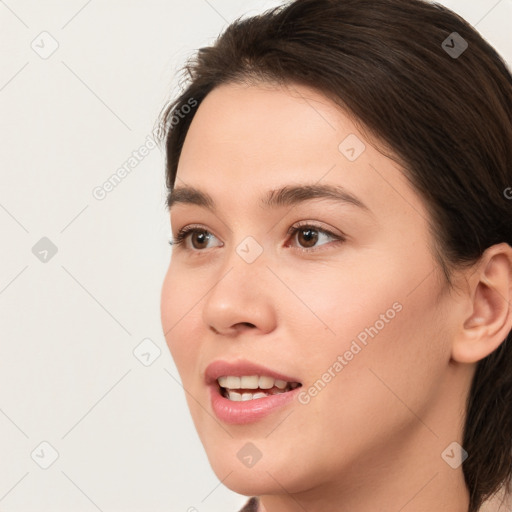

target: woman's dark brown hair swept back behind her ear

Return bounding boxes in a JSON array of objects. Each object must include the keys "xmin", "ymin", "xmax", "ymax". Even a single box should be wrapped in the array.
[{"xmin": 159, "ymin": 0, "xmax": 512, "ymax": 512}]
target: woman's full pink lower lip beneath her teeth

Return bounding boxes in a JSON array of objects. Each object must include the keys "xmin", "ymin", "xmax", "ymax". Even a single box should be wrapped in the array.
[{"xmin": 210, "ymin": 384, "xmax": 301, "ymax": 425}]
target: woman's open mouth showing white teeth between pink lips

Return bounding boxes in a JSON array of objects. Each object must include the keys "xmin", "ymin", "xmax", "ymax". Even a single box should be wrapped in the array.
[{"xmin": 217, "ymin": 375, "xmax": 302, "ymax": 402}]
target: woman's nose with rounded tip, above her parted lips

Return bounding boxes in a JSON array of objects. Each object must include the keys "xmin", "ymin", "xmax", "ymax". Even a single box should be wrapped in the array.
[{"xmin": 202, "ymin": 243, "xmax": 276, "ymax": 337}]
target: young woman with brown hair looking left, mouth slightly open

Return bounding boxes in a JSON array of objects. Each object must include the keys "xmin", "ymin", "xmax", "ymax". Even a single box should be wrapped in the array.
[{"xmin": 161, "ymin": 0, "xmax": 512, "ymax": 512}]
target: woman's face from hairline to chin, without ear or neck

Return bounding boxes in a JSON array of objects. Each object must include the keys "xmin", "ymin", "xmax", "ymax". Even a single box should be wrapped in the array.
[{"xmin": 161, "ymin": 85, "xmax": 464, "ymax": 502}]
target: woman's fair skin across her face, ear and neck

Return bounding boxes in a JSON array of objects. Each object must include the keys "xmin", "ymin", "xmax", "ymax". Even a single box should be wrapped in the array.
[{"xmin": 161, "ymin": 84, "xmax": 512, "ymax": 512}]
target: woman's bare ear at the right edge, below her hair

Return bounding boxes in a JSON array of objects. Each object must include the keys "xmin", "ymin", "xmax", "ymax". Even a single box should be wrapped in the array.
[{"xmin": 452, "ymin": 243, "xmax": 512, "ymax": 363}]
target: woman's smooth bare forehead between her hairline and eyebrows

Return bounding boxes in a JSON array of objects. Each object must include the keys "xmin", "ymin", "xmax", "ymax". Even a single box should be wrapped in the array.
[{"xmin": 175, "ymin": 84, "xmax": 428, "ymax": 230}]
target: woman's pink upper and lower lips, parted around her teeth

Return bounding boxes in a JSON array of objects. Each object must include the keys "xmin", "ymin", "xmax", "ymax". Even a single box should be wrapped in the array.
[{"xmin": 205, "ymin": 360, "xmax": 300, "ymax": 425}]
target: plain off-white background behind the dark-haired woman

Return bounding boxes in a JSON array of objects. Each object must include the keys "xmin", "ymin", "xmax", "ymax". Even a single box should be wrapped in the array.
[{"xmin": 0, "ymin": 0, "xmax": 512, "ymax": 512}]
